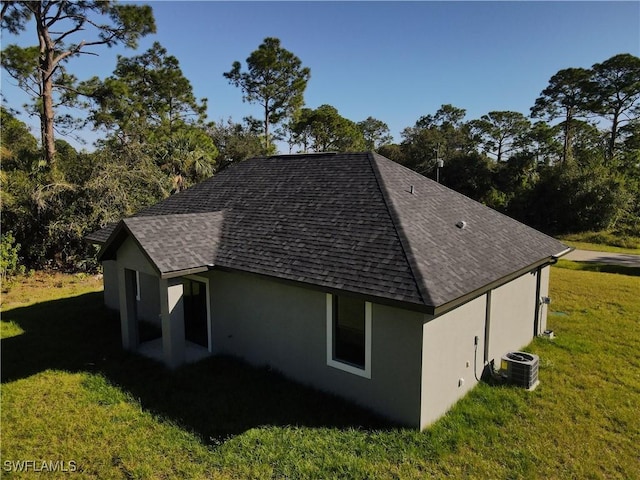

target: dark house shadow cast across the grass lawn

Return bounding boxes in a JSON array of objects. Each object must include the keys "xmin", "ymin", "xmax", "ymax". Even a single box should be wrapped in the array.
[{"xmin": 1, "ymin": 292, "xmax": 397, "ymax": 444}]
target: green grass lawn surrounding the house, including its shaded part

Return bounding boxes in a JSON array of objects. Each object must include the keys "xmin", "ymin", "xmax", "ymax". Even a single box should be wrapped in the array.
[{"xmin": 0, "ymin": 267, "xmax": 640, "ymax": 479}]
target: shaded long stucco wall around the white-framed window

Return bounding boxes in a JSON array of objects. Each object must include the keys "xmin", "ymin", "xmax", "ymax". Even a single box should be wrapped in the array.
[{"xmin": 209, "ymin": 271, "xmax": 423, "ymax": 427}]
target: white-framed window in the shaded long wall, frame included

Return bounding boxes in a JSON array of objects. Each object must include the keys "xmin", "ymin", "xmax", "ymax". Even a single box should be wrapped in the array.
[{"xmin": 327, "ymin": 294, "xmax": 371, "ymax": 378}]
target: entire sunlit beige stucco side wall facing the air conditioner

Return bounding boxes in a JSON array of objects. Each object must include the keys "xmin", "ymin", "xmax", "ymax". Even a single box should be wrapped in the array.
[{"xmin": 420, "ymin": 267, "xmax": 549, "ymax": 428}]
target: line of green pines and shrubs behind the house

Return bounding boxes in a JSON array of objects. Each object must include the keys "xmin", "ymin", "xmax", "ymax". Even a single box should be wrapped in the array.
[{"xmin": 0, "ymin": 0, "xmax": 640, "ymax": 278}]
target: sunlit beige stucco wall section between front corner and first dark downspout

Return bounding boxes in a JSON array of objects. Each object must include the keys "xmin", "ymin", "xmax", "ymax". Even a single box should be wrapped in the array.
[{"xmin": 420, "ymin": 295, "xmax": 487, "ymax": 428}]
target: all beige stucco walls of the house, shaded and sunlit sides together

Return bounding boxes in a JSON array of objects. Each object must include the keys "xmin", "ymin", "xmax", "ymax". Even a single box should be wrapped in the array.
[{"xmin": 104, "ymin": 234, "xmax": 549, "ymax": 428}]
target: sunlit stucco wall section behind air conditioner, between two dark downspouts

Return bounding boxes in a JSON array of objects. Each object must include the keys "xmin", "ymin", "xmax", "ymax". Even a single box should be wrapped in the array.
[{"xmin": 488, "ymin": 271, "xmax": 537, "ymax": 366}]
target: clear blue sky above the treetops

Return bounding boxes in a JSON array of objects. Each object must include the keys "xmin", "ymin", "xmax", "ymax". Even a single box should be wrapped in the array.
[{"xmin": 2, "ymin": 1, "xmax": 640, "ymax": 150}]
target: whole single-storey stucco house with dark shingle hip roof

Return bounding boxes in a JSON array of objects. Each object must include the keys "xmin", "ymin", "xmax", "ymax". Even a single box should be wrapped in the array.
[{"xmin": 88, "ymin": 153, "xmax": 569, "ymax": 428}]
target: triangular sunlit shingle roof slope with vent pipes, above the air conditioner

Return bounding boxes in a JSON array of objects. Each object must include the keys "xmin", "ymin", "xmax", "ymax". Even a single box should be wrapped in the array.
[{"xmin": 373, "ymin": 154, "xmax": 567, "ymax": 305}]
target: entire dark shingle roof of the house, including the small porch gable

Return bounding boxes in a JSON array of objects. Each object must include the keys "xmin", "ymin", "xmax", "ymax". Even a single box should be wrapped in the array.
[{"xmin": 90, "ymin": 153, "xmax": 566, "ymax": 310}]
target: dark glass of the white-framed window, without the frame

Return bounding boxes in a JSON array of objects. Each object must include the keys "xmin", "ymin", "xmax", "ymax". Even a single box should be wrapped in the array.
[{"xmin": 333, "ymin": 296, "xmax": 365, "ymax": 368}]
